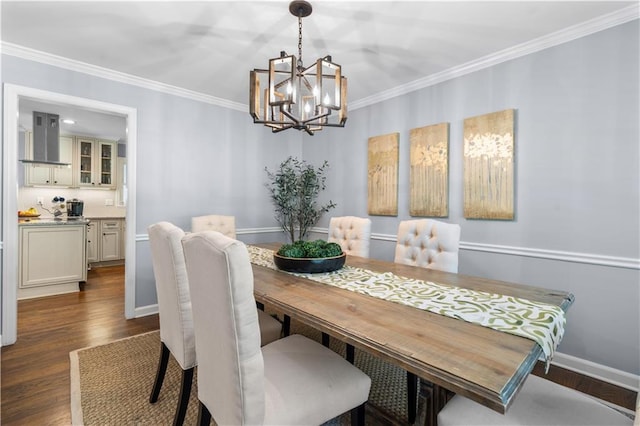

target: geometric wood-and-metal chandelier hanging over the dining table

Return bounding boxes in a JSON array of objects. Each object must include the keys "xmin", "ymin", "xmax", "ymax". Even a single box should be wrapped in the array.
[{"xmin": 249, "ymin": 1, "xmax": 347, "ymax": 135}]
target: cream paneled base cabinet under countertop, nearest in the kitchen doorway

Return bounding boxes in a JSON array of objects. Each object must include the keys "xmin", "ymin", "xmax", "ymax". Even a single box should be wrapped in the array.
[{"xmin": 18, "ymin": 224, "xmax": 87, "ymax": 299}]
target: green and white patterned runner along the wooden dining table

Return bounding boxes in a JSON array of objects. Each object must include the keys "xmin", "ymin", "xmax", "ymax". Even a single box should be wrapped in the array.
[{"xmin": 247, "ymin": 246, "xmax": 566, "ymax": 369}]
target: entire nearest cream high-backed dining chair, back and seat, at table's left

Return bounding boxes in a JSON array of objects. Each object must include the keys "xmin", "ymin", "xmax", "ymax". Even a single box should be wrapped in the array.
[{"xmin": 182, "ymin": 231, "xmax": 371, "ymax": 425}]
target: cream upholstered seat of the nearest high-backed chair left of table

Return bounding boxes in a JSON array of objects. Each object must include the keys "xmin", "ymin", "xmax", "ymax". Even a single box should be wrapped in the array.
[{"xmin": 262, "ymin": 334, "xmax": 371, "ymax": 425}]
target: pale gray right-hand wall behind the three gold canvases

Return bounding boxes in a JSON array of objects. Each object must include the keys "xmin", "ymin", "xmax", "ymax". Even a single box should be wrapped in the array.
[{"xmin": 303, "ymin": 21, "xmax": 640, "ymax": 374}]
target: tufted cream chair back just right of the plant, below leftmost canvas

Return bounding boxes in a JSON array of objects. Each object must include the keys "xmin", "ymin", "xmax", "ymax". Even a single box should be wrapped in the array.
[{"xmin": 327, "ymin": 216, "xmax": 371, "ymax": 257}]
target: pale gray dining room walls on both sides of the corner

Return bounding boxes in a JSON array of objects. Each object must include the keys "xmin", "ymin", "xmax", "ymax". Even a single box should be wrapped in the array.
[{"xmin": 2, "ymin": 21, "xmax": 640, "ymax": 374}]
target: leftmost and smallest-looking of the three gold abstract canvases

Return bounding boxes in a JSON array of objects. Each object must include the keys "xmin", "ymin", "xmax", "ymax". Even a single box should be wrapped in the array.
[{"xmin": 367, "ymin": 133, "xmax": 399, "ymax": 216}]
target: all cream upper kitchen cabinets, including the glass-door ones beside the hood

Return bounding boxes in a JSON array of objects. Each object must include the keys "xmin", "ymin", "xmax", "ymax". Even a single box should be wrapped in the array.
[{"xmin": 25, "ymin": 132, "xmax": 117, "ymax": 189}]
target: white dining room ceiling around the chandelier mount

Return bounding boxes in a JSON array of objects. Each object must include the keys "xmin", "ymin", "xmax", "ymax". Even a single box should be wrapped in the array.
[{"xmin": 0, "ymin": 0, "xmax": 638, "ymax": 136}]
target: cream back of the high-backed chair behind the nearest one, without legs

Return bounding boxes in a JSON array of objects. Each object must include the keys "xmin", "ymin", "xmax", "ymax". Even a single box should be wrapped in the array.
[{"xmin": 148, "ymin": 222, "xmax": 196, "ymax": 370}]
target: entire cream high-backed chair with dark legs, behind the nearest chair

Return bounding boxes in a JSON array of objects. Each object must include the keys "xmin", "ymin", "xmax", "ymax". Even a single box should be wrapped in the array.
[{"xmin": 148, "ymin": 222, "xmax": 282, "ymax": 425}]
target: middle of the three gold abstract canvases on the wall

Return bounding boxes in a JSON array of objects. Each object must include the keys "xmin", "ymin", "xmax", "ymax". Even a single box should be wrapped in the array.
[{"xmin": 409, "ymin": 123, "xmax": 449, "ymax": 217}]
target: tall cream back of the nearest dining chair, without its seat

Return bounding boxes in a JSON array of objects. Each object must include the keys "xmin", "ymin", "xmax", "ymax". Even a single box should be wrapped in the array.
[{"xmin": 183, "ymin": 231, "xmax": 265, "ymax": 425}]
